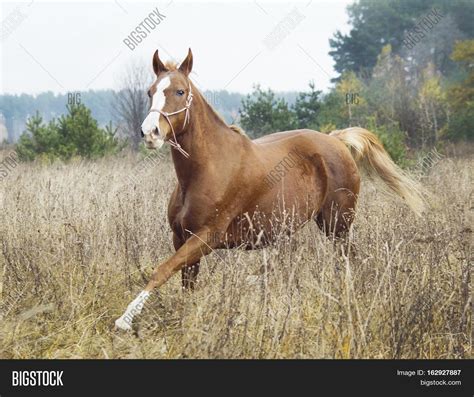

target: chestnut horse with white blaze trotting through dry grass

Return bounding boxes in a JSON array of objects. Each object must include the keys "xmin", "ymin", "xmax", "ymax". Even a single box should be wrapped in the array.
[{"xmin": 115, "ymin": 49, "xmax": 424, "ymax": 330}]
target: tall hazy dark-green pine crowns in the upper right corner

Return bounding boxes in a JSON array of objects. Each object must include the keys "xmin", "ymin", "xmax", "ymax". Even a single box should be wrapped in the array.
[{"xmin": 329, "ymin": 0, "xmax": 474, "ymax": 79}]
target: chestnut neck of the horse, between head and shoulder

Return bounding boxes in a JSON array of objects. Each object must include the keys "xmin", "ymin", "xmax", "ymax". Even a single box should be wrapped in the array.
[{"xmin": 171, "ymin": 96, "xmax": 237, "ymax": 190}]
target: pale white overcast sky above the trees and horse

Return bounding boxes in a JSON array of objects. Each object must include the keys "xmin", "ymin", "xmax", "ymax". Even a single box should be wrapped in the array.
[{"xmin": 0, "ymin": 0, "xmax": 352, "ymax": 94}]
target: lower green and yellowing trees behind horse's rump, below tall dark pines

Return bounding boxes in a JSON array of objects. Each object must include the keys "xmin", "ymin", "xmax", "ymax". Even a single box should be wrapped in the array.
[{"xmin": 240, "ymin": 40, "xmax": 474, "ymax": 162}]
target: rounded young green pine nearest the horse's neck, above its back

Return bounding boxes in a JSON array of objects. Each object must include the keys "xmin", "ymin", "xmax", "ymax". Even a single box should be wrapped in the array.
[{"xmin": 239, "ymin": 86, "xmax": 296, "ymax": 138}]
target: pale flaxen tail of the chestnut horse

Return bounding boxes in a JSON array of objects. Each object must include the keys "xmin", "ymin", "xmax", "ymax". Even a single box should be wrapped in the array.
[{"xmin": 330, "ymin": 127, "xmax": 425, "ymax": 215}]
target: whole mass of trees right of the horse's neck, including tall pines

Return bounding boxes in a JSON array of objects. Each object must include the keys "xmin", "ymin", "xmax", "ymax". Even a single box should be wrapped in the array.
[{"xmin": 240, "ymin": 0, "xmax": 474, "ymax": 162}]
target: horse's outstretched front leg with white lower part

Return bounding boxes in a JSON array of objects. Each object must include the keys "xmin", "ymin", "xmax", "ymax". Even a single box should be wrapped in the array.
[{"xmin": 115, "ymin": 228, "xmax": 216, "ymax": 330}]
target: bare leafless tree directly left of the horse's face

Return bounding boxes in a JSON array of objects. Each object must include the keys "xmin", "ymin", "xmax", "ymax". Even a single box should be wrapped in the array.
[{"xmin": 114, "ymin": 61, "xmax": 152, "ymax": 149}]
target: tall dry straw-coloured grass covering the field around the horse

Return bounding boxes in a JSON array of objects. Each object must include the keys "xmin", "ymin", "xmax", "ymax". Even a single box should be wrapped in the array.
[{"xmin": 0, "ymin": 147, "xmax": 474, "ymax": 358}]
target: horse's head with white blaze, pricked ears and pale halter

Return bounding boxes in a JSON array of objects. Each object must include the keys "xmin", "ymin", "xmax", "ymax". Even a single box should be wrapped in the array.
[{"xmin": 141, "ymin": 49, "xmax": 193, "ymax": 149}]
